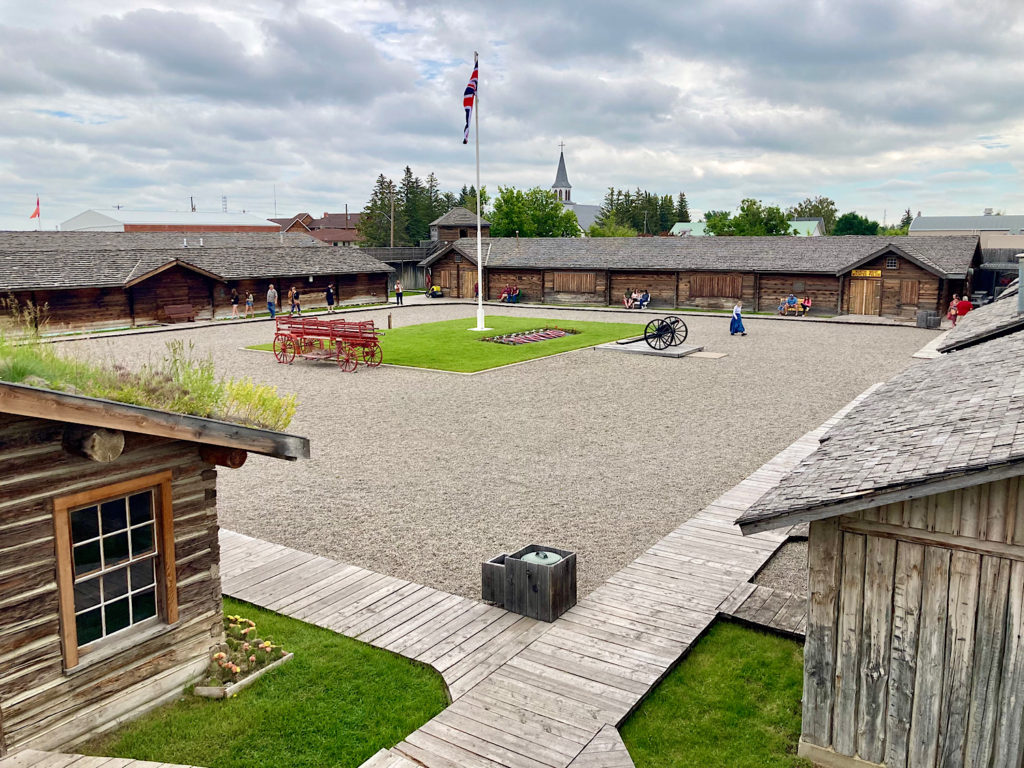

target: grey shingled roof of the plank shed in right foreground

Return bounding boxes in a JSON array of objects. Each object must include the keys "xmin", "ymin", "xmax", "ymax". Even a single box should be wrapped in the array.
[{"xmin": 737, "ymin": 333, "xmax": 1024, "ymax": 532}]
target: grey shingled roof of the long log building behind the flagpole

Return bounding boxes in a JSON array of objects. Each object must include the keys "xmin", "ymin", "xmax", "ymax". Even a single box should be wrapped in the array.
[{"xmin": 421, "ymin": 236, "xmax": 978, "ymax": 278}]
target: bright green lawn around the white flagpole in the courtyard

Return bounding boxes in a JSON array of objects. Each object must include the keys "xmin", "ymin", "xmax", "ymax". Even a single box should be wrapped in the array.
[{"xmin": 250, "ymin": 315, "xmax": 644, "ymax": 373}]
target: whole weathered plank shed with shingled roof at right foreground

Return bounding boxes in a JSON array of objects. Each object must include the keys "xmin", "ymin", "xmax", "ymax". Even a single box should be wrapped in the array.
[{"xmin": 738, "ymin": 309, "xmax": 1024, "ymax": 768}]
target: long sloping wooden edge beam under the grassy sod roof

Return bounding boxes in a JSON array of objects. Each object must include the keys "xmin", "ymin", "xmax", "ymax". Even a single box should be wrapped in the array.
[{"xmin": 0, "ymin": 382, "xmax": 309, "ymax": 459}]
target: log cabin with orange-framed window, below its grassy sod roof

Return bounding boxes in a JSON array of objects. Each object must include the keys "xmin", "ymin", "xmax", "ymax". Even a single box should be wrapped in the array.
[{"xmin": 0, "ymin": 383, "xmax": 309, "ymax": 757}]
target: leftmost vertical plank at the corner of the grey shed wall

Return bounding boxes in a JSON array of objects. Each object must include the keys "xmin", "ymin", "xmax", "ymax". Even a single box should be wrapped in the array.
[{"xmin": 801, "ymin": 518, "xmax": 843, "ymax": 746}]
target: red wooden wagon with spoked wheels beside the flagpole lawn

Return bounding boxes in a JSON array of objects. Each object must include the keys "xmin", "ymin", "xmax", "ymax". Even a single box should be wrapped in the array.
[{"xmin": 273, "ymin": 316, "xmax": 384, "ymax": 371}]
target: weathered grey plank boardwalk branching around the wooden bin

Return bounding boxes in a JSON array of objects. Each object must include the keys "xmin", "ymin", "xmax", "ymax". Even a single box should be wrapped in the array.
[{"xmin": 211, "ymin": 393, "xmax": 866, "ymax": 768}]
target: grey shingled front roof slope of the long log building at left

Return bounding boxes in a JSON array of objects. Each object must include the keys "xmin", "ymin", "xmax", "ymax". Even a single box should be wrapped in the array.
[{"xmin": 0, "ymin": 247, "xmax": 393, "ymax": 291}]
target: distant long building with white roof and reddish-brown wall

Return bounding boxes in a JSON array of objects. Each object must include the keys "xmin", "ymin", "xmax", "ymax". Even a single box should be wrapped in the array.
[{"xmin": 60, "ymin": 209, "xmax": 281, "ymax": 232}]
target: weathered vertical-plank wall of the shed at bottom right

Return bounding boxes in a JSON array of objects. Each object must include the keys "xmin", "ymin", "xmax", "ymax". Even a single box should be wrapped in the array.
[{"xmin": 801, "ymin": 477, "xmax": 1024, "ymax": 768}]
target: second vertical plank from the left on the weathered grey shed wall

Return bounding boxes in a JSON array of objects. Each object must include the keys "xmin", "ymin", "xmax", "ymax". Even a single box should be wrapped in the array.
[{"xmin": 833, "ymin": 534, "xmax": 865, "ymax": 756}]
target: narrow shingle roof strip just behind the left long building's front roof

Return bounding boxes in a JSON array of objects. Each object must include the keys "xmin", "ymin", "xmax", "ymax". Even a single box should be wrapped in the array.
[{"xmin": 0, "ymin": 230, "xmax": 326, "ymax": 253}]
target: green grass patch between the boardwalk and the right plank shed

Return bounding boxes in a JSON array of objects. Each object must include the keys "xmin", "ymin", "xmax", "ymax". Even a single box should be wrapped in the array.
[{"xmin": 622, "ymin": 622, "xmax": 811, "ymax": 768}]
